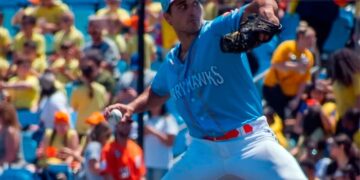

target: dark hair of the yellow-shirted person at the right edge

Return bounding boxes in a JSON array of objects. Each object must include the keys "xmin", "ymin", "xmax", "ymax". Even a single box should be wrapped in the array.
[{"xmin": 330, "ymin": 48, "xmax": 360, "ymax": 86}]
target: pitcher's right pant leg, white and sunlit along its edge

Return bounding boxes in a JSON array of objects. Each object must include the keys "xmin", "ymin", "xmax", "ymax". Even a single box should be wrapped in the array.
[{"xmin": 225, "ymin": 127, "xmax": 307, "ymax": 180}]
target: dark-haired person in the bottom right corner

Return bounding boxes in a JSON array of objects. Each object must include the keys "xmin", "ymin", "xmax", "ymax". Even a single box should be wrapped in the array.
[{"xmin": 326, "ymin": 134, "xmax": 360, "ymax": 179}]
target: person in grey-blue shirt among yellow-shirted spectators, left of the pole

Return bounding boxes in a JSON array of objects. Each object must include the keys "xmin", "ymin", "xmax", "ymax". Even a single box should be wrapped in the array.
[{"xmin": 84, "ymin": 16, "xmax": 120, "ymax": 67}]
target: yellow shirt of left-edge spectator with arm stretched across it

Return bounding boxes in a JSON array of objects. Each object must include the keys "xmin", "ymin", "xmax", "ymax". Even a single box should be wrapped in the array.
[{"xmin": 9, "ymin": 76, "xmax": 40, "ymax": 109}]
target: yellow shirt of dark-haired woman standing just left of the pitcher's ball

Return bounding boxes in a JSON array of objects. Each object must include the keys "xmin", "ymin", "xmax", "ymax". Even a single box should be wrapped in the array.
[{"xmin": 71, "ymin": 82, "xmax": 106, "ymax": 135}]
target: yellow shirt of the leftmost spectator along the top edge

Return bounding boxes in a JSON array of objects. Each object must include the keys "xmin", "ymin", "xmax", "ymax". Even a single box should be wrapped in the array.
[{"xmin": 31, "ymin": 2, "xmax": 69, "ymax": 24}]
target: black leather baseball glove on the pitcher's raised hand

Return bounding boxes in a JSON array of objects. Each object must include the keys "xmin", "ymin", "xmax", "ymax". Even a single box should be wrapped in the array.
[{"xmin": 220, "ymin": 14, "xmax": 282, "ymax": 53}]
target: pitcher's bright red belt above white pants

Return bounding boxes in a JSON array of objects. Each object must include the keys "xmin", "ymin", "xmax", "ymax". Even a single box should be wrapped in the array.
[{"xmin": 204, "ymin": 124, "xmax": 253, "ymax": 141}]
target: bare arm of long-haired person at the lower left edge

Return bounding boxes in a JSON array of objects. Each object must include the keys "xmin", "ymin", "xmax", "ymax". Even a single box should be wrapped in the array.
[{"xmin": 0, "ymin": 128, "xmax": 20, "ymax": 165}]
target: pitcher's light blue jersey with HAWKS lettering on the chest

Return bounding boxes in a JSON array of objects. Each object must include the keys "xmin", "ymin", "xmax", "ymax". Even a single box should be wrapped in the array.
[{"xmin": 151, "ymin": 7, "xmax": 262, "ymax": 138}]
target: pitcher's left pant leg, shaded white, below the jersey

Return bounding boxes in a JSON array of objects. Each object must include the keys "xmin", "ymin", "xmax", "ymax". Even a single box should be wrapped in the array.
[{"xmin": 163, "ymin": 139, "xmax": 224, "ymax": 180}]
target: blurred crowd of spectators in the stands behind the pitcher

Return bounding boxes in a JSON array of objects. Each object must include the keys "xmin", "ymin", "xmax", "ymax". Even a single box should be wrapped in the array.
[{"xmin": 0, "ymin": 0, "xmax": 360, "ymax": 180}]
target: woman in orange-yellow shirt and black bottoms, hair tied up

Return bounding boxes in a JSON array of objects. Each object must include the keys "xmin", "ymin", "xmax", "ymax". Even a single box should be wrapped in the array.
[{"xmin": 263, "ymin": 25, "xmax": 315, "ymax": 119}]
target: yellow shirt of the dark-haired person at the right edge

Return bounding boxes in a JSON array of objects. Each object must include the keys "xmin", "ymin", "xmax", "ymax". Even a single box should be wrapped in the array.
[{"xmin": 333, "ymin": 73, "xmax": 360, "ymax": 117}]
